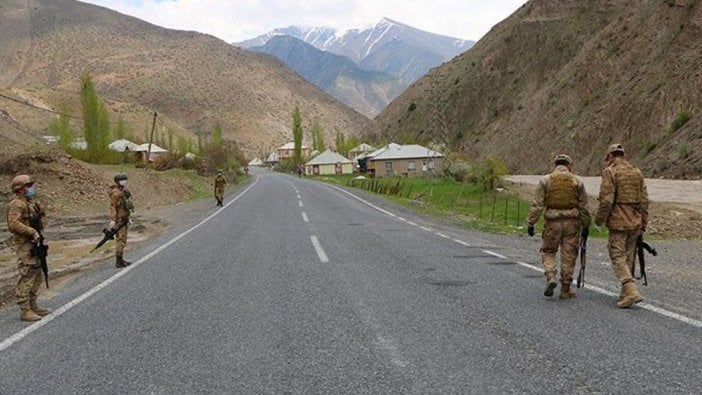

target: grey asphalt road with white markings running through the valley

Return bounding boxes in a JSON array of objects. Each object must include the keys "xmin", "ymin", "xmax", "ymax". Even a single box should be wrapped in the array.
[{"xmin": 0, "ymin": 173, "xmax": 702, "ymax": 394}]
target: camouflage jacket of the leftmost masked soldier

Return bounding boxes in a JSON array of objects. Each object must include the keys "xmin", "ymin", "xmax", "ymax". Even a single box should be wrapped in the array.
[{"xmin": 7, "ymin": 196, "xmax": 44, "ymax": 264}]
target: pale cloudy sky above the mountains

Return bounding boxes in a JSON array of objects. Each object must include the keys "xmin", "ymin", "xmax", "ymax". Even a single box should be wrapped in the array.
[{"xmin": 81, "ymin": 0, "xmax": 526, "ymax": 43}]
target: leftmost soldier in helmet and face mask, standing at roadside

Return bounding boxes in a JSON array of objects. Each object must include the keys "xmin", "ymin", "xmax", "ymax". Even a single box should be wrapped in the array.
[{"xmin": 7, "ymin": 174, "xmax": 51, "ymax": 321}]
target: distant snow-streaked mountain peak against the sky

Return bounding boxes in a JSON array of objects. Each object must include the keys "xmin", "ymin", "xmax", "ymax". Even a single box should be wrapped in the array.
[{"xmin": 234, "ymin": 18, "xmax": 474, "ymax": 117}]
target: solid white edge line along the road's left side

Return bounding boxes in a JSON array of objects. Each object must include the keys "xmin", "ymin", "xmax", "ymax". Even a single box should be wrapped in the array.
[{"xmin": 0, "ymin": 178, "xmax": 258, "ymax": 352}]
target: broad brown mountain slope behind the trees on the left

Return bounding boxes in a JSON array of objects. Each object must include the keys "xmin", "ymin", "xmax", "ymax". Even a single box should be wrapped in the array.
[{"xmin": 0, "ymin": 0, "xmax": 368, "ymax": 154}]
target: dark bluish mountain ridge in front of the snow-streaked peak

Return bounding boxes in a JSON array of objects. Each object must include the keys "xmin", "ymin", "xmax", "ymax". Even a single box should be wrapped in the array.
[{"xmin": 249, "ymin": 35, "xmax": 405, "ymax": 118}]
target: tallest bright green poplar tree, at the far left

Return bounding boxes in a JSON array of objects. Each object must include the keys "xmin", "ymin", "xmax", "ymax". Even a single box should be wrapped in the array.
[{"xmin": 80, "ymin": 74, "xmax": 110, "ymax": 163}]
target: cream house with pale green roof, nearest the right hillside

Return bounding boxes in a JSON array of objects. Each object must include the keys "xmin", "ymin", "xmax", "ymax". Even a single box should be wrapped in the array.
[{"xmin": 366, "ymin": 143, "xmax": 444, "ymax": 177}]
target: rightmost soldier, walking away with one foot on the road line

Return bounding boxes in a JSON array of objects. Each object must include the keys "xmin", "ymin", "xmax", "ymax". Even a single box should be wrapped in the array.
[{"xmin": 595, "ymin": 144, "xmax": 648, "ymax": 309}]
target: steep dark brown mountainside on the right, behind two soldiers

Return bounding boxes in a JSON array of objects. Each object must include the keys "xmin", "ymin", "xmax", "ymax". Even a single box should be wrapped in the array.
[{"xmin": 366, "ymin": 0, "xmax": 702, "ymax": 178}]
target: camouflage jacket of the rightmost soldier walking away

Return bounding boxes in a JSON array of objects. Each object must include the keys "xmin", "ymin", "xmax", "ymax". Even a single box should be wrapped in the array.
[{"xmin": 595, "ymin": 157, "xmax": 648, "ymax": 230}]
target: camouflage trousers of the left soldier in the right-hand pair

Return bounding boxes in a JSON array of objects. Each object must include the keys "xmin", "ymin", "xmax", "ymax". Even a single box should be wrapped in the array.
[{"xmin": 541, "ymin": 219, "xmax": 580, "ymax": 284}]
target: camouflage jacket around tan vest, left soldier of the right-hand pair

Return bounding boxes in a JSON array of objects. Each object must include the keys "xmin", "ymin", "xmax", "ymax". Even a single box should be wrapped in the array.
[{"xmin": 527, "ymin": 165, "xmax": 590, "ymax": 226}]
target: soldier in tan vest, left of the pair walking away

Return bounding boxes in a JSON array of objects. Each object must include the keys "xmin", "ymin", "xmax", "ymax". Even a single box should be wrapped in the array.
[{"xmin": 527, "ymin": 154, "xmax": 590, "ymax": 299}]
